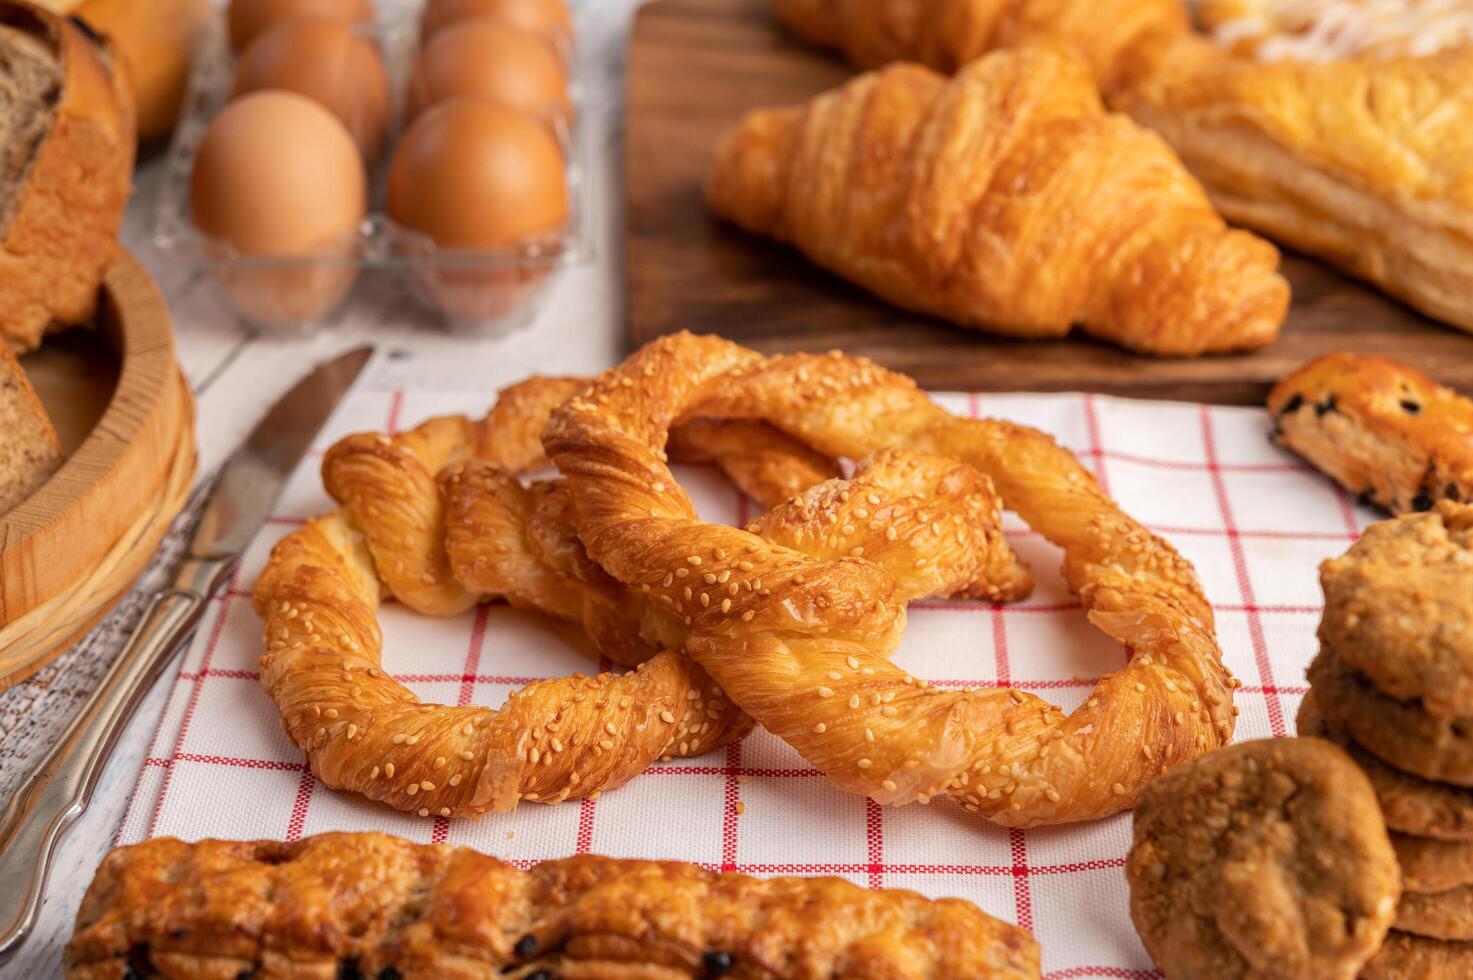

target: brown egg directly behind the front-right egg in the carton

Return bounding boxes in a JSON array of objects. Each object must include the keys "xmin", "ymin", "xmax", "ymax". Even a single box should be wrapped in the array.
[{"xmin": 408, "ymin": 18, "xmax": 572, "ymax": 119}]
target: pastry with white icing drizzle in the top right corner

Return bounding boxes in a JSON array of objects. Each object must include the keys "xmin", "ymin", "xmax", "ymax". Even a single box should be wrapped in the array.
[{"xmin": 1196, "ymin": 0, "xmax": 1473, "ymax": 62}]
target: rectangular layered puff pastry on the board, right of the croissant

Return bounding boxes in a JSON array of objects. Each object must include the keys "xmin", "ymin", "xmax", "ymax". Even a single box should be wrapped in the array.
[{"xmin": 1115, "ymin": 40, "xmax": 1473, "ymax": 330}]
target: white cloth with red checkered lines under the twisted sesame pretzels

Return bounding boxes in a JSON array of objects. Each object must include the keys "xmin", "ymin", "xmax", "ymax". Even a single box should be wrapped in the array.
[{"xmin": 119, "ymin": 386, "xmax": 1376, "ymax": 980}]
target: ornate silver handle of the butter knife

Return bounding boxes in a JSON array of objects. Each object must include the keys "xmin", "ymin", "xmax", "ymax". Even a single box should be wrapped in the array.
[{"xmin": 0, "ymin": 588, "xmax": 205, "ymax": 956}]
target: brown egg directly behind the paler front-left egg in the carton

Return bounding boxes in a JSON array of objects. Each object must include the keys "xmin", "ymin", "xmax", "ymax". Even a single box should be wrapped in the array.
[{"xmin": 230, "ymin": 18, "xmax": 389, "ymax": 161}]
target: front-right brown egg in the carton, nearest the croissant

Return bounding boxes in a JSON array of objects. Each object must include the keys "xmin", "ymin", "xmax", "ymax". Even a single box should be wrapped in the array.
[{"xmin": 389, "ymin": 99, "xmax": 567, "ymax": 249}]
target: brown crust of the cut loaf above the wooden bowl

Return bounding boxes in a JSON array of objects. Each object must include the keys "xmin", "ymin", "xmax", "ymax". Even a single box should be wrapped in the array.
[{"xmin": 0, "ymin": 0, "xmax": 134, "ymax": 351}]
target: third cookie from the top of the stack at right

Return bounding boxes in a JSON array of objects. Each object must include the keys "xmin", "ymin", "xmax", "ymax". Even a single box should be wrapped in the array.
[{"xmin": 1298, "ymin": 691, "xmax": 1473, "ymax": 841}]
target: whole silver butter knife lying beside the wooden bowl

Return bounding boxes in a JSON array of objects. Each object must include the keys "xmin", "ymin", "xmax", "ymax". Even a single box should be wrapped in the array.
[{"xmin": 0, "ymin": 348, "xmax": 373, "ymax": 956}]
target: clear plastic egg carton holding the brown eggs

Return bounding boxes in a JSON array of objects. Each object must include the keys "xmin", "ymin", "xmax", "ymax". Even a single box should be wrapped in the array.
[{"xmin": 152, "ymin": 12, "xmax": 594, "ymax": 336}]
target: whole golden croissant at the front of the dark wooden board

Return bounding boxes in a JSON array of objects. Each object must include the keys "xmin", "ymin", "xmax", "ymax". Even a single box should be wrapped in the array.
[{"xmin": 707, "ymin": 49, "xmax": 1289, "ymax": 355}]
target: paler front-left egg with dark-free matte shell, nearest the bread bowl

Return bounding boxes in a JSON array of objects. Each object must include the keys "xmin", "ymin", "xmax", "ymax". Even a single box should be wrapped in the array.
[{"xmin": 190, "ymin": 91, "xmax": 367, "ymax": 324}]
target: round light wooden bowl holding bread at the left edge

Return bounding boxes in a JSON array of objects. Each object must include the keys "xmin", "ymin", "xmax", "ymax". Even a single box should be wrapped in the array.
[{"xmin": 0, "ymin": 252, "xmax": 194, "ymax": 690}]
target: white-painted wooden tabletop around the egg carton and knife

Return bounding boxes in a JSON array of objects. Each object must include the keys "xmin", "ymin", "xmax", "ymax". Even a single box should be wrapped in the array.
[{"xmin": 0, "ymin": 0, "xmax": 639, "ymax": 980}]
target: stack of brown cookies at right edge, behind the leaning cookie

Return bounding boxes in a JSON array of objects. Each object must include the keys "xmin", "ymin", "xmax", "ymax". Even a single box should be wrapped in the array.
[{"xmin": 1299, "ymin": 501, "xmax": 1473, "ymax": 954}]
